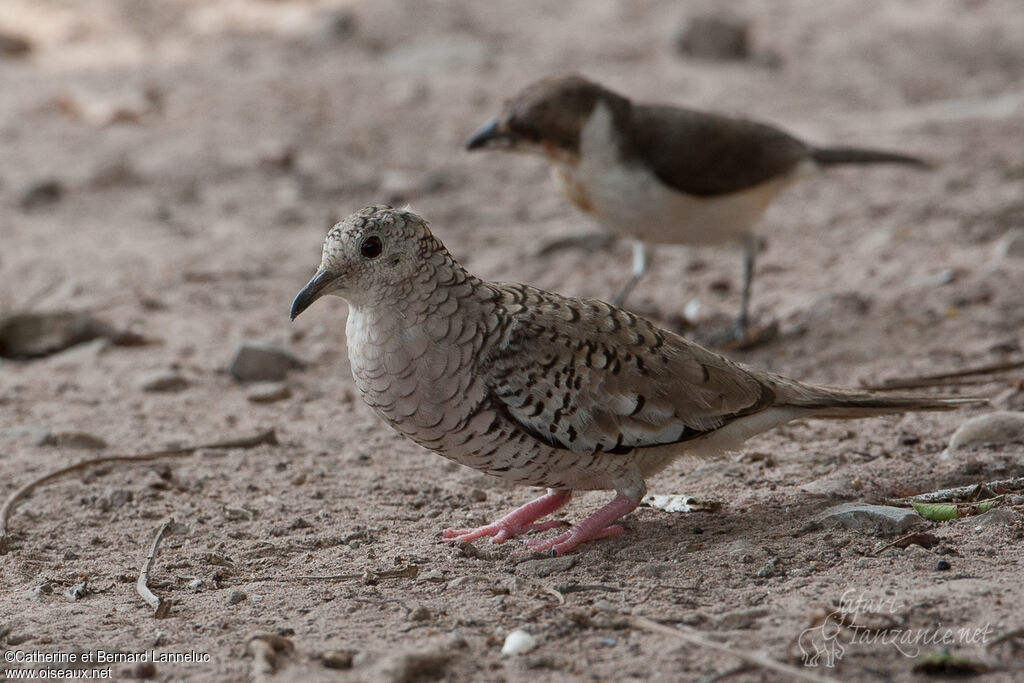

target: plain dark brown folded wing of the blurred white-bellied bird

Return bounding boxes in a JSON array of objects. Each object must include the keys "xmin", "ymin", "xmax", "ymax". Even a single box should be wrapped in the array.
[{"xmin": 624, "ymin": 104, "xmax": 811, "ymax": 197}]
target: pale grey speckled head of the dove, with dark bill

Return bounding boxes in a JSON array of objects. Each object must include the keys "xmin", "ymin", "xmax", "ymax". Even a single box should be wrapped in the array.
[{"xmin": 291, "ymin": 206, "xmax": 451, "ymax": 321}]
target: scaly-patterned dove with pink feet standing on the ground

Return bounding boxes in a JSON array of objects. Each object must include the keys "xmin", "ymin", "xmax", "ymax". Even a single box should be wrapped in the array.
[{"xmin": 291, "ymin": 207, "xmax": 973, "ymax": 554}]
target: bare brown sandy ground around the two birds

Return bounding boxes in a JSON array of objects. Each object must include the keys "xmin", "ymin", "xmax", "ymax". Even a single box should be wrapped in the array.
[{"xmin": 0, "ymin": 0, "xmax": 1024, "ymax": 681}]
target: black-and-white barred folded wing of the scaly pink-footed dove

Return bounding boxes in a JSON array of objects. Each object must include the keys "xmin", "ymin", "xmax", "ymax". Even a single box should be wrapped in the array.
[{"xmin": 479, "ymin": 290, "xmax": 772, "ymax": 453}]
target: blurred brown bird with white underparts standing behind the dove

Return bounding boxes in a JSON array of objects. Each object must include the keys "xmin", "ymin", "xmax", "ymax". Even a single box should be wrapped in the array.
[{"xmin": 466, "ymin": 76, "xmax": 927, "ymax": 339}]
